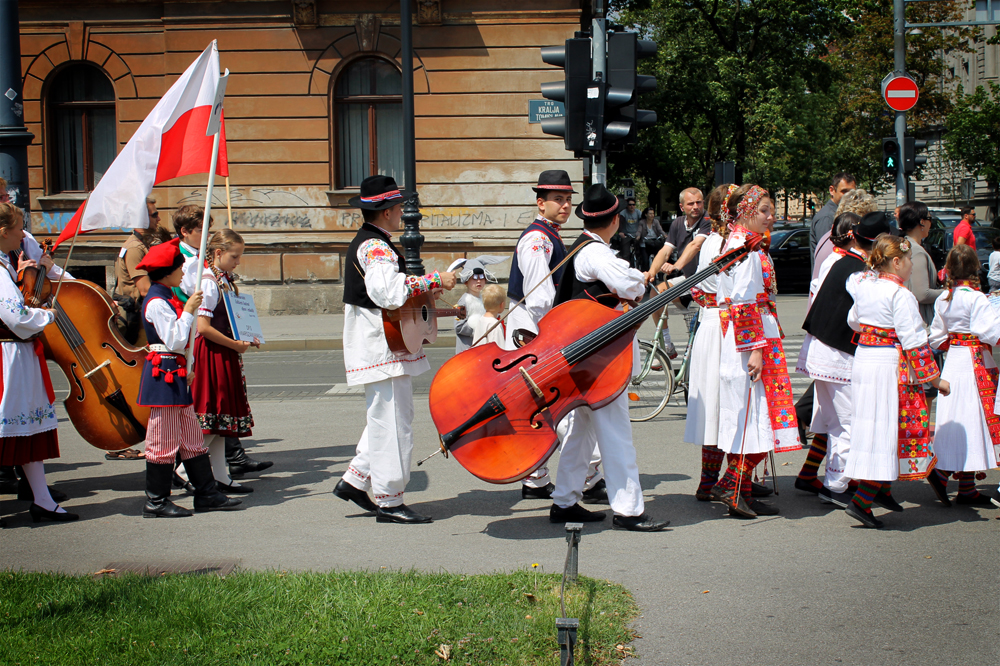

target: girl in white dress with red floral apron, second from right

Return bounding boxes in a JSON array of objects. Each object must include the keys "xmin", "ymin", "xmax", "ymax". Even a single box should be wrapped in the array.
[{"xmin": 844, "ymin": 234, "xmax": 950, "ymax": 528}]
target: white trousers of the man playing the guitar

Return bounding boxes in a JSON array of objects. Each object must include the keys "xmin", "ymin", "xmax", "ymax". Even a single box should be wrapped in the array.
[{"xmin": 344, "ymin": 375, "xmax": 413, "ymax": 508}]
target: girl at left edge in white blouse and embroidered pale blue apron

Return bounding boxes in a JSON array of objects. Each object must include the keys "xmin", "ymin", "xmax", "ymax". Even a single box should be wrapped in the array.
[{"xmin": 0, "ymin": 203, "xmax": 79, "ymax": 523}]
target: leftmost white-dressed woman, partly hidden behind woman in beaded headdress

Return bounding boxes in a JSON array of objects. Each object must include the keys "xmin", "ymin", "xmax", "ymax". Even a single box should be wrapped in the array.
[{"xmin": 684, "ymin": 185, "xmax": 736, "ymax": 502}]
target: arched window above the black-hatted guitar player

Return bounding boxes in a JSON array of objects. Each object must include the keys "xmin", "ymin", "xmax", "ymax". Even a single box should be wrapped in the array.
[{"xmin": 333, "ymin": 58, "xmax": 405, "ymax": 189}]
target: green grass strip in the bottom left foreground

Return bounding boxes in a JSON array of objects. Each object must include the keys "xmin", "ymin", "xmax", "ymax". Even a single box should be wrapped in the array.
[{"xmin": 0, "ymin": 570, "xmax": 638, "ymax": 666}]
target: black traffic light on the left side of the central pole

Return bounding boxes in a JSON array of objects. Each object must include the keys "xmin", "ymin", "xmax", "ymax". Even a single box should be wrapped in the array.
[{"xmin": 541, "ymin": 38, "xmax": 593, "ymax": 151}]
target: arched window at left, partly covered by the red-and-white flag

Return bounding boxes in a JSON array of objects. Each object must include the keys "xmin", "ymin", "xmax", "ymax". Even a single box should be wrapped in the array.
[{"xmin": 47, "ymin": 63, "xmax": 118, "ymax": 194}]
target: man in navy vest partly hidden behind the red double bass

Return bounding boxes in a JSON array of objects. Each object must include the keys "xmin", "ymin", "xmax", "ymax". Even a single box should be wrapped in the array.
[{"xmin": 505, "ymin": 170, "xmax": 607, "ymax": 502}]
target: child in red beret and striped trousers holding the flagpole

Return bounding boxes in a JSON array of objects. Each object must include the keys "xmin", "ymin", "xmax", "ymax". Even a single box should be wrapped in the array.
[{"xmin": 137, "ymin": 238, "xmax": 240, "ymax": 518}]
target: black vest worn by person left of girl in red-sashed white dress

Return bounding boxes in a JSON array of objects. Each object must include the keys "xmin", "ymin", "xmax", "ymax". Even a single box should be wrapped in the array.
[{"xmin": 802, "ymin": 252, "xmax": 868, "ymax": 356}]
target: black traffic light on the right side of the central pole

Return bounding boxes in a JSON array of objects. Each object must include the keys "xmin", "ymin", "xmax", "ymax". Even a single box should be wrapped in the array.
[{"xmin": 602, "ymin": 32, "xmax": 656, "ymax": 150}]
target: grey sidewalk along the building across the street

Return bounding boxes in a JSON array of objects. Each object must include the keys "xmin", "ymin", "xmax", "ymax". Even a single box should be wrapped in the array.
[{"xmin": 250, "ymin": 294, "xmax": 806, "ymax": 352}]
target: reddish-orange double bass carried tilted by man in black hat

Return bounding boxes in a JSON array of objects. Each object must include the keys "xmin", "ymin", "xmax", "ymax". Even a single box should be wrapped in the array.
[{"xmin": 430, "ymin": 235, "xmax": 760, "ymax": 483}]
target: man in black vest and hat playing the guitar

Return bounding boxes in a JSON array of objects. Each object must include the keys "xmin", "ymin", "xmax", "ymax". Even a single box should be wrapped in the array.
[{"xmin": 333, "ymin": 176, "xmax": 455, "ymax": 523}]
